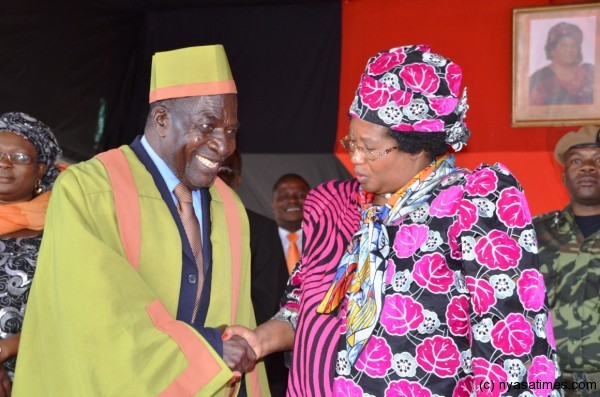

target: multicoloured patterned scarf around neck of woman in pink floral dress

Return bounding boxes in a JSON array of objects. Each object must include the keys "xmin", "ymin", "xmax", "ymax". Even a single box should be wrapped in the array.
[{"xmin": 317, "ymin": 154, "xmax": 455, "ymax": 364}]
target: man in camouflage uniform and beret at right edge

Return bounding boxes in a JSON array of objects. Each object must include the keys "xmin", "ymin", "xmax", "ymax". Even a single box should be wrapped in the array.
[{"xmin": 534, "ymin": 126, "xmax": 600, "ymax": 396}]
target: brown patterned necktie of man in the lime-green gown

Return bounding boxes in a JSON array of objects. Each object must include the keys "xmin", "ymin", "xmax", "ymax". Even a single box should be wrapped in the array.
[{"xmin": 173, "ymin": 183, "xmax": 204, "ymax": 322}]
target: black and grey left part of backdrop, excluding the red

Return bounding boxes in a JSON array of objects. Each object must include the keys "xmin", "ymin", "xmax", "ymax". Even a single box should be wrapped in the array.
[{"xmin": 0, "ymin": 0, "xmax": 349, "ymax": 215}]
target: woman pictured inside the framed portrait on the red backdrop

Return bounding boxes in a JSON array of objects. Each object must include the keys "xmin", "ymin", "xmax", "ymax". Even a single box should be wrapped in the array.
[{"xmin": 529, "ymin": 22, "xmax": 594, "ymax": 105}]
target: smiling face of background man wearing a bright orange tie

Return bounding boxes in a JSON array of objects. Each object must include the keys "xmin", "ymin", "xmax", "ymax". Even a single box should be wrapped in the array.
[{"xmin": 273, "ymin": 178, "xmax": 309, "ymax": 231}]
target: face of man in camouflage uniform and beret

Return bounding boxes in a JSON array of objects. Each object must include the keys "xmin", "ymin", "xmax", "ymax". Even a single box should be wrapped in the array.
[{"xmin": 563, "ymin": 147, "xmax": 600, "ymax": 206}]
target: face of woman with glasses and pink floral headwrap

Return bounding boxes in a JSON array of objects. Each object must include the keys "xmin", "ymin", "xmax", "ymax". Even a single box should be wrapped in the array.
[{"xmin": 349, "ymin": 118, "xmax": 429, "ymax": 194}]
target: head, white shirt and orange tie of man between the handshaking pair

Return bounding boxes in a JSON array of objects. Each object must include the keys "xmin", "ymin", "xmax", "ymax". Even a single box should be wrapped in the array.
[{"xmin": 272, "ymin": 174, "xmax": 310, "ymax": 274}]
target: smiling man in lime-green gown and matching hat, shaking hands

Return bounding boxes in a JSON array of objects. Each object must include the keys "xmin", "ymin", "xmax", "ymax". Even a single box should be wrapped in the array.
[{"xmin": 13, "ymin": 45, "xmax": 269, "ymax": 397}]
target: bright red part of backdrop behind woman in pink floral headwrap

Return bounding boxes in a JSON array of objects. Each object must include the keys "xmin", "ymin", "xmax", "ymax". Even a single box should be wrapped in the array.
[{"xmin": 336, "ymin": 0, "xmax": 596, "ymax": 215}]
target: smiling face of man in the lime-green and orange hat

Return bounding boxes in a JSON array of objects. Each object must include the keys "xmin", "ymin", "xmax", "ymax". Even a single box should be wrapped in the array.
[{"xmin": 159, "ymin": 94, "xmax": 238, "ymax": 189}]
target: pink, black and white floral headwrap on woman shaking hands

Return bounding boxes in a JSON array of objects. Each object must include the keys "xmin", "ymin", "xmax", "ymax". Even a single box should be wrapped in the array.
[{"xmin": 350, "ymin": 45, "xmax": 471, "ymax": 151}]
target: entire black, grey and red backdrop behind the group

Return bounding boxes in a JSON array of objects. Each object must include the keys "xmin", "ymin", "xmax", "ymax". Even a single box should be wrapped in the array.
[{"xmin": 0, "ymin": 0, "xmax": 600, "ymax": 214}]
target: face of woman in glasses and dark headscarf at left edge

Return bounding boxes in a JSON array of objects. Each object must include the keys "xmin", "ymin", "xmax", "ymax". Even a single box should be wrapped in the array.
[{"xmin": 0, "ymin": 131, "xmax": 46, "ymax": 204}]
